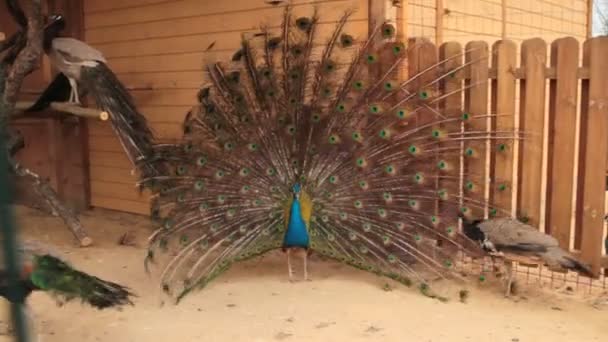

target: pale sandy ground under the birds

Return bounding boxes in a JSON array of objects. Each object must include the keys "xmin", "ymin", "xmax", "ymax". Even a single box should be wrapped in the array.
[{"xmin": 0, "ymin": 207, "xmax": 608, "ymax": 342}]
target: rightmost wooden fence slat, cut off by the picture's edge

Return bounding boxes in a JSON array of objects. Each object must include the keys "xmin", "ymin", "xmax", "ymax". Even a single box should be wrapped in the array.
[{"xmin": 577, "ymin": 37, "xmax": 608, "ymax": 275}]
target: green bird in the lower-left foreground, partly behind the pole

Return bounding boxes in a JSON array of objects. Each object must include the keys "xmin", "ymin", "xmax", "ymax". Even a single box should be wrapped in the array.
[{"xmin": 0, "ymin": 241, "xmax": 134, "ymax": 309}]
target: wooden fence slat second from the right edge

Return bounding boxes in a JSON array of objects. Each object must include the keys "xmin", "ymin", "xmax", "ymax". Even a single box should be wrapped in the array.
[{"xmin": 545, "ymin": 37, "xmax": 579, "ymax": 250}]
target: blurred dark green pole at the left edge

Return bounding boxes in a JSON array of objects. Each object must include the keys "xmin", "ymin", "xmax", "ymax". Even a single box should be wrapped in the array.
[{"xmin": 0, "ymin": 64, "xmax": 29, "ymax": 342}]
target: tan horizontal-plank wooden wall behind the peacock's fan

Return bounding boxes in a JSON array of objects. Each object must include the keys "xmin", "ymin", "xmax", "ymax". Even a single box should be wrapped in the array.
[{"xmin": 85, "ymin": 0, "xmax": 368, "ymax": 214}]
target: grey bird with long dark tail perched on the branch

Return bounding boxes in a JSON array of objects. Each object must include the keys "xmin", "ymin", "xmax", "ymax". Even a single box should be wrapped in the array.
[{"xmin": 43, "ymin": 15, "xmax": 166, "ymax": 182}]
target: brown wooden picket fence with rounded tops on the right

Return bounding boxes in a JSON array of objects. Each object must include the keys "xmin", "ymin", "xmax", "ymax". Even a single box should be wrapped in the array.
[{"xmin": 408, "ymin": 37, "xmax": 608, "ymax": 275}]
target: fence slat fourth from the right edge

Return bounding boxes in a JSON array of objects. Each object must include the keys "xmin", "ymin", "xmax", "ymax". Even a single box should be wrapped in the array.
[{"xmin": 490, "ymin": 40, "xmax": 517, "ymax": 214}]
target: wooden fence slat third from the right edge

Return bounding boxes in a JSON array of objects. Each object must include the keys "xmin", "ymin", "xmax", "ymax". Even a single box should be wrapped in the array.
[{"xmin": 517, "ymin": 38, "xmax": 547, "ymax": 227}]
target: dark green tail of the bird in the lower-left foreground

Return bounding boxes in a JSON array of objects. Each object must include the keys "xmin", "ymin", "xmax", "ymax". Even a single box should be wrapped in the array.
[{"xmin": 30, "ymin": 254, "xmax": 135, "ymax": 309}]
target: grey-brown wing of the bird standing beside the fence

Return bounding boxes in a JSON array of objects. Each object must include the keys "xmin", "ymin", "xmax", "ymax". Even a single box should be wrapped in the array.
[{"xmin": 479, "ymin": 218, "xmax": 558, "ymax": 252}]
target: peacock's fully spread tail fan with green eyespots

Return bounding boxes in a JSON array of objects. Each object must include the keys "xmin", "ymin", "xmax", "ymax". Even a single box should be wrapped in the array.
[{"xmin": 143, "ymin": 7, "xmax": 516, "ymax": 299}]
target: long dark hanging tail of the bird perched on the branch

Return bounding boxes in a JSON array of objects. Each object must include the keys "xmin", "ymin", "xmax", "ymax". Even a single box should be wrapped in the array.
[{"xmin": 81, "ymin": 62, "xmax": 165, "ymax": 184}]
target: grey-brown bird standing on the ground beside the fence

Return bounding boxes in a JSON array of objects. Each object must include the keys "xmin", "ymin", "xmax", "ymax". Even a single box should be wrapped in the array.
[{"xmin": 460, "ymin": 214, "xmax": 593, "ymax": 296}]
